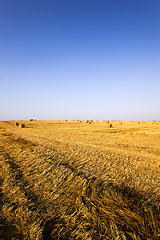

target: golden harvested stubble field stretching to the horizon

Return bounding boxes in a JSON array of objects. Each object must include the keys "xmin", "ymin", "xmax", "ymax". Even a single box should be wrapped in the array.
[{"xmin": 0, "ymin": 121, "xmax": 160, "ymax": 240}]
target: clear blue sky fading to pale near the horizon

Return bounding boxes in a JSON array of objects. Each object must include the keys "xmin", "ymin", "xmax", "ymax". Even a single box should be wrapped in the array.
[{"xmin": 0, "ymin": 0, "xmax": 160, "ymax": 120}]
